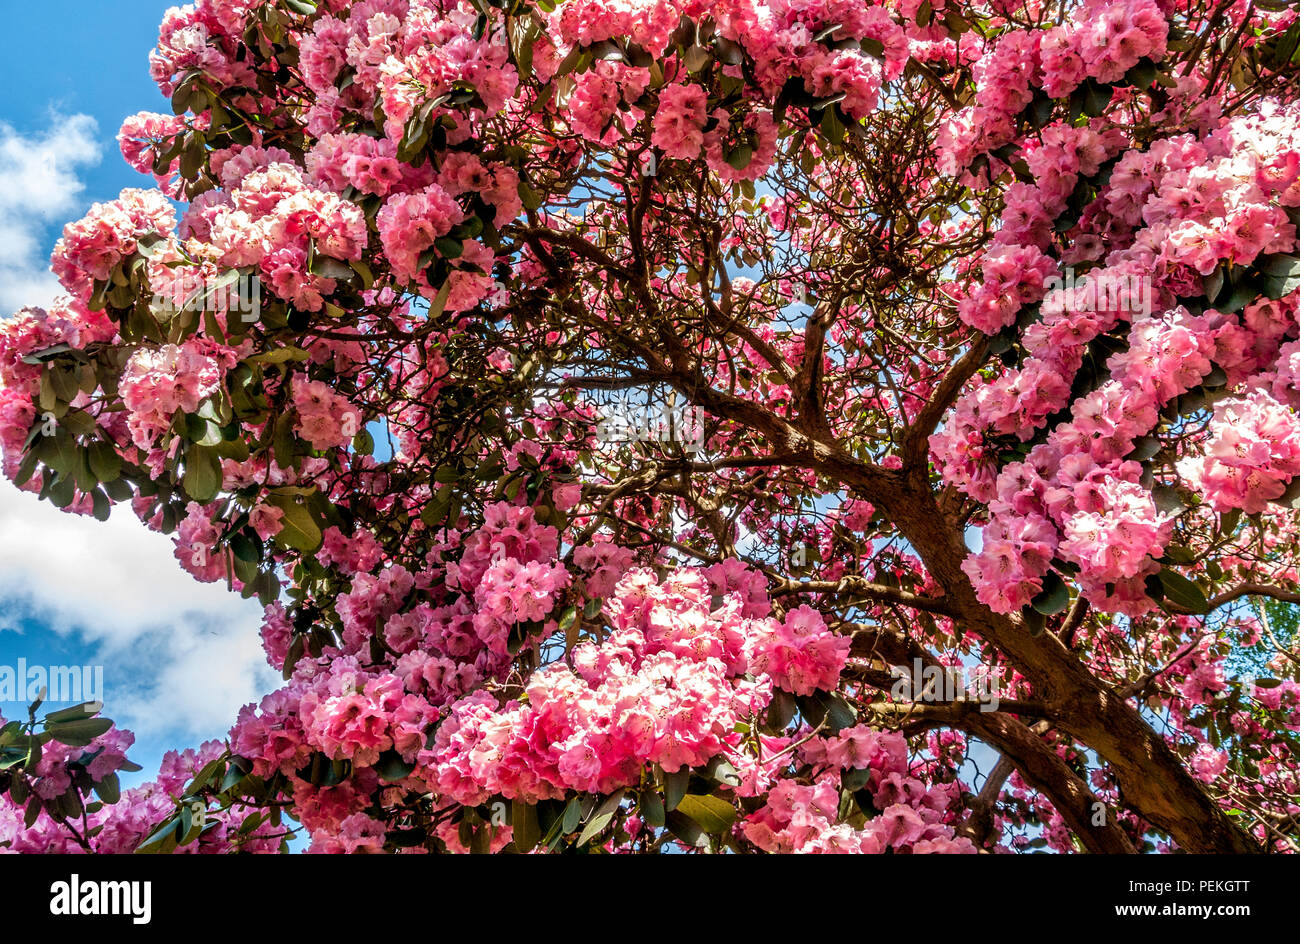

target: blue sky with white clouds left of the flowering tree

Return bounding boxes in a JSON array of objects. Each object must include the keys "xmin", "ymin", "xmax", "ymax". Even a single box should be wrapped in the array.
[{"xmin": 0, "ymin": 0, "xmax": 278, "ymax": 783}]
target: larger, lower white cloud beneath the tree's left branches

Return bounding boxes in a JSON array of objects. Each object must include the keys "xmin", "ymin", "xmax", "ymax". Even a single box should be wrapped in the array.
[{"xmin": 0, "ymin": 482, "xmax": 281, "ymax": 746}]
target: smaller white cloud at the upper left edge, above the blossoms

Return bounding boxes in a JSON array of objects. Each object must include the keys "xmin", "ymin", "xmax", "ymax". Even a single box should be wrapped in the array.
[{"xmin": 0, "ymin": 114, "xmax": 100, "ymax": 315}]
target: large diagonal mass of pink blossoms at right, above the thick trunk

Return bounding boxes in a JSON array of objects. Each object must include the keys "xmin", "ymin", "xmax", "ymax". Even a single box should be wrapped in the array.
[{"xmin": 931, "ymin": 103, "xmax": 1300, "ymax": 611}]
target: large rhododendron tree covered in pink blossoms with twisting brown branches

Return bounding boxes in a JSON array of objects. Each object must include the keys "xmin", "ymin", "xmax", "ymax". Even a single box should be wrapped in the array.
[{"xmin": 0, "ymin": 0, "xmax": 1300, "ymax": 853}]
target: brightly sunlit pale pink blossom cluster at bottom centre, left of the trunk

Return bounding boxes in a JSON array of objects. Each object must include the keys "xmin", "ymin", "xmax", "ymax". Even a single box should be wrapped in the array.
[{"xmin": 421, "ymin": 570, "xmax": 772, "ymax": 804}]
